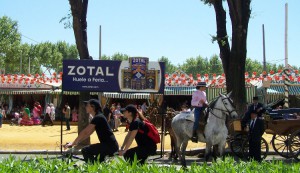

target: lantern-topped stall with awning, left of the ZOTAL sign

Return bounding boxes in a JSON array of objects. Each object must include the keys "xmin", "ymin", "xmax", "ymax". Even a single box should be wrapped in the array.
[{"xmin": 0, "ymin": 73, "xmax": 61, "ymax": 119}]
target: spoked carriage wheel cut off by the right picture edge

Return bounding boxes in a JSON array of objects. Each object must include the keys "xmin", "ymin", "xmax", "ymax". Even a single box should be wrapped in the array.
[{"xmin": 289, "ymin": 129, "xmax": 300, "ymax": 161}]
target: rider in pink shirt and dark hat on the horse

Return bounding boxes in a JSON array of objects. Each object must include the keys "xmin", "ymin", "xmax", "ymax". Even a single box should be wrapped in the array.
[{"xmin": 191, "ymin": 82, "xmax": 208, "ymax": 143}]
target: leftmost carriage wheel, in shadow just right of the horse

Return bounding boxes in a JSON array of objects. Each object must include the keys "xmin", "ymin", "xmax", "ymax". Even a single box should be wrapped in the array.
[{"xmin": 230, "ymin": 134, "xmax": 247, "ymax": 158}]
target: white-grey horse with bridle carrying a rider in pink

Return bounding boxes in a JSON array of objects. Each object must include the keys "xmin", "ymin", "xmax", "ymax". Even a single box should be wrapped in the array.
[{"xmin": 171, "ymin": 92, "xmax": 238, "ymax": 167}]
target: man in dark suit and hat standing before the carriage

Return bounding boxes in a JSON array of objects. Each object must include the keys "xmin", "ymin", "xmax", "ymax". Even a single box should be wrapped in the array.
[{"xmin": 248, "ymin": 110, "xmax": 265, "ymax": 162}]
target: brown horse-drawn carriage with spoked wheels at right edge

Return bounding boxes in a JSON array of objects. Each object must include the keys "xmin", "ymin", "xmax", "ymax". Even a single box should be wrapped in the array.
[{"xmin": 228, "ymin": 108, "xmax": 300, "ymax": 160}]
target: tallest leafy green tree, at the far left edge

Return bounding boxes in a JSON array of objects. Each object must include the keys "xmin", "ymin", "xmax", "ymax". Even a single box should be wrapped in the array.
[{"xmin": 0, "ymin": 16, "xmax": 21, "ymax": 73}]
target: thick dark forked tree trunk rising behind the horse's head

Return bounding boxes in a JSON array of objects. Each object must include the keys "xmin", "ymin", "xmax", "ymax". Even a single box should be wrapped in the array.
[{"xmin": 213, "ymin": 0, "xmax": 251, "ymax": 115}]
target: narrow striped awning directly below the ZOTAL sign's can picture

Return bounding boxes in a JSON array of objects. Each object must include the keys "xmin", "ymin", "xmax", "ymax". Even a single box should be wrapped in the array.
[{"xmin": 103, "ymin": 92, "xmax": 150, "ymax": 99}]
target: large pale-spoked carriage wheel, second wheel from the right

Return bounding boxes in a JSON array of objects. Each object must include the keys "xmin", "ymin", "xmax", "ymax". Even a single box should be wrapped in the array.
[{"xmin": 272, "ymin": 135, "xmax": 293, "ymax": 158}]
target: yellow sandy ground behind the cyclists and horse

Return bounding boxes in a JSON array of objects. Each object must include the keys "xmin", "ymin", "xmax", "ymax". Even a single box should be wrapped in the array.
[{"xmin": 0, "ymin": 124, "xmax": 272, "ymax": 151}]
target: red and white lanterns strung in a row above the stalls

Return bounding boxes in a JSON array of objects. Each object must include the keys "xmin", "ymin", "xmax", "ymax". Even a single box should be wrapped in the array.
[{"xmin": 0, "ymin": 70, "xmax": 300, "ymax": 87}]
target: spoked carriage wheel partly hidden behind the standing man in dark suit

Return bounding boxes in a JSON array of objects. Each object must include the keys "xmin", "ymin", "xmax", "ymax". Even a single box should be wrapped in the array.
[{"xmin": 242, "ymin": 137, "xmax": 269, "ymax": 160}]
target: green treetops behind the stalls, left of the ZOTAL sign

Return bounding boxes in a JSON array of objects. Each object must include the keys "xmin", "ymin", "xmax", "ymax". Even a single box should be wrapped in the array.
[{"xmin": 0, "ymin": 16, "xmax": 79, "ymax": 74}]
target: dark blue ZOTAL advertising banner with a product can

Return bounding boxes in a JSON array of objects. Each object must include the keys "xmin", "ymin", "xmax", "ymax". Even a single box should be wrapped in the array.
[{"xmin": 62, "ymin": 57, "xmax": 165, "ymax": 93}]
